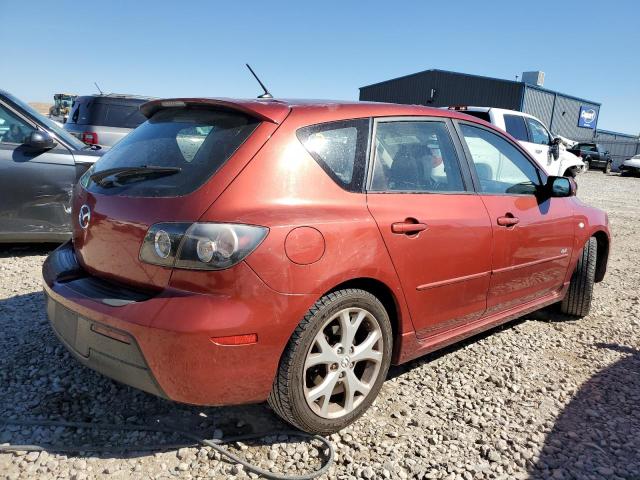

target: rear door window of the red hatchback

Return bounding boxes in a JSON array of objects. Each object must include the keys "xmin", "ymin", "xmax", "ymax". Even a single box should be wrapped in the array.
[{"xmin": 369, "ymin": 121, "xmax": 465, "ymax": 193}]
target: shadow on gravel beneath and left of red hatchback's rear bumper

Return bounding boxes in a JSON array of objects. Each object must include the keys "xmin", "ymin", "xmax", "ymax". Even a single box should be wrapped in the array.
[{"xmin": 0, "ymin": 292, "xmax": 308, "ymax": 458}]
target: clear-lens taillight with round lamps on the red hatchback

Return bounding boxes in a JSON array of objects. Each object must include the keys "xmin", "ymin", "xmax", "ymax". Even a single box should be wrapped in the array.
[{"xmin": 140, "ymin": 223, "xmax": 269, "ymax": 270}]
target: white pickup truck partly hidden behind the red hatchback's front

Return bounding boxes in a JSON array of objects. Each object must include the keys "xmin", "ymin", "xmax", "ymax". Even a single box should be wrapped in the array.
[{"xmin": 449, "ymin": 106, "xmax": 585, "ymax": 177}]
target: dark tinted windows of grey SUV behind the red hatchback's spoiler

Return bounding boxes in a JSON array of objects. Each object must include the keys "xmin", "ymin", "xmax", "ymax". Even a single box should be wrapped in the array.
[{"xmin": 67, "ymin": 97, "xmax": 146, "ymax": 128}]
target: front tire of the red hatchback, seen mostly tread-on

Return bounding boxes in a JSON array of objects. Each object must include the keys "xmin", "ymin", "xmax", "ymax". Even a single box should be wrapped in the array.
[{"xmin": 560, "ymin": 237, "xmax": 598, "ymax": 318}]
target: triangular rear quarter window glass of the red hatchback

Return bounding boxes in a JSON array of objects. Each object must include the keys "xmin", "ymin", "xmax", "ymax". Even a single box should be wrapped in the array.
[{"xmin": 297, "ymin": 118, "xmax": 370, "ymax": 192}]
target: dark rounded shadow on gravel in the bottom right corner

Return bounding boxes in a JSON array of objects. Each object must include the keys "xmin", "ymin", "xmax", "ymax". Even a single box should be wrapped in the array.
[{"xmin": 529, "ymin": 344, "xmax": 640, "ymax": 480}]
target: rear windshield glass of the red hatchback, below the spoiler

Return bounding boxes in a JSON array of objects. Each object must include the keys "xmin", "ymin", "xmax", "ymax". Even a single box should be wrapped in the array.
[{"xmin": 81, "ymin": 108, "xmax": 259, "ymax": 197}]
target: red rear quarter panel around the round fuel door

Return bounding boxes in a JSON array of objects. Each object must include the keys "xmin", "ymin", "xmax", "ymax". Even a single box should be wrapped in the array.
[{"xmin": 201, "ymin": 111, "xmax": 413, "ymax": 331}]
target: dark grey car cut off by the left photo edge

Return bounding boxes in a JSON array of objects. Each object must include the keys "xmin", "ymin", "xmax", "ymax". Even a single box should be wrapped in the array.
[{"xmin": 0, "ymin": 90, "xmax": 102, "ymax": 242}]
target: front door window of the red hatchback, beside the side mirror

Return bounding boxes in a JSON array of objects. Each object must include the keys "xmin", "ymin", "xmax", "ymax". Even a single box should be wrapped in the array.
[{"xmin": 460, "ymin": 124, "xmax": 541, "ymax": 195}]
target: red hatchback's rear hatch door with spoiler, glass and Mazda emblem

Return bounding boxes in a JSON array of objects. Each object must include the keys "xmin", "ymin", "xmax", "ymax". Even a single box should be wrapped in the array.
[{"xmin": 72, "ymin": 99, "xmax": 289, "ymax": 290}]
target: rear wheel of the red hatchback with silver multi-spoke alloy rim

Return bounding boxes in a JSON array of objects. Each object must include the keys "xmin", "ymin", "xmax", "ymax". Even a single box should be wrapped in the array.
[{"xmin": 268, "ymin": 289, "xmax": 393, "ymax": 435}]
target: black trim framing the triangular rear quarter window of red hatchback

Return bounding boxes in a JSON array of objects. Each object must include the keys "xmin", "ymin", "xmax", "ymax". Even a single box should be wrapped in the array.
[{"xmin": 296, "ymin": 117, "xmax": 373, "ymax": 193}]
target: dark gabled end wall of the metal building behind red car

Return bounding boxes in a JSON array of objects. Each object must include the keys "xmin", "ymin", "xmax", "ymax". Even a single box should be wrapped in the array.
[{"xmin": 360, "ymin": 70, "xmax": 524, "ymax": 110}]
